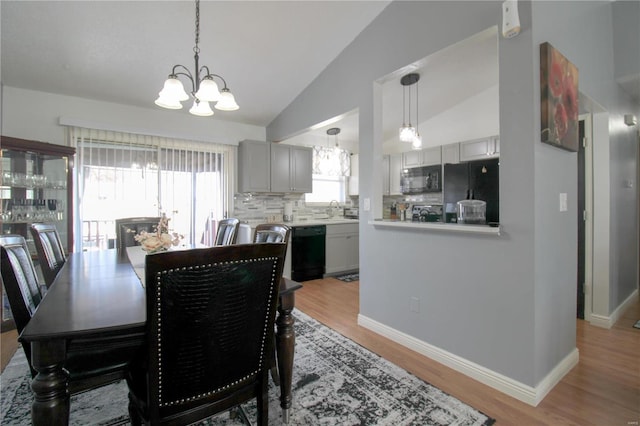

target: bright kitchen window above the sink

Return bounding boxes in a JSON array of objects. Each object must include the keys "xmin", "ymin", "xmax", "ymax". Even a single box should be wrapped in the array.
[{"xmin": 305, "ymin": 146, "xmax": 351, "ymax": 204}]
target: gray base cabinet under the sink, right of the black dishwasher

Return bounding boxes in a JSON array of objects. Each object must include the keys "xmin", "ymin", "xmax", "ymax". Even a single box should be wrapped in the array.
[{"xmin": 325, "ymin": 223, "xmax": 360, "ymax": 275}]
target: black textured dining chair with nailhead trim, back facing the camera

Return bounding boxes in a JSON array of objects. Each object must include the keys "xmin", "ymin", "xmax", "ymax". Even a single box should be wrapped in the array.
[{"xmin": 127, "ymin": 244, "xmax": 286, "ymax": 425}]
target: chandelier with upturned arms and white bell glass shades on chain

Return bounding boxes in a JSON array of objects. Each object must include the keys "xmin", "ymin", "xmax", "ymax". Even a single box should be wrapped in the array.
[{"xmin": 155, "ymin": 0, "xmax": 240, "ymax": 117}]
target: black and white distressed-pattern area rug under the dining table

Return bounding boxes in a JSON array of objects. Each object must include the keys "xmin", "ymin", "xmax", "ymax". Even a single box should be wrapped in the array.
[{"xmin": 0, "ymin": 310, "xmax": 495, "ymax": 426}]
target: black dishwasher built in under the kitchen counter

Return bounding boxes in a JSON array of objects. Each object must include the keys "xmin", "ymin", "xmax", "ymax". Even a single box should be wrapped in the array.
[{"xmin": 291, "ymin": 225, "xmax": 327, "ymax": 281}]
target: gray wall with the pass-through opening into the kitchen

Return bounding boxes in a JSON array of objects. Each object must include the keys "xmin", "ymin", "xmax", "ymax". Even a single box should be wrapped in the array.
[{"xmin": 267, "ymin": 1, "xmax": 544, "ymax": 388}]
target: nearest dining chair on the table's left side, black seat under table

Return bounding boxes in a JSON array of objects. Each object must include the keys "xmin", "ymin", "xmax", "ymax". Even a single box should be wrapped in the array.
[{"xmin": 0, "ymin": 235, "xmax": 138, "ymax": 393}]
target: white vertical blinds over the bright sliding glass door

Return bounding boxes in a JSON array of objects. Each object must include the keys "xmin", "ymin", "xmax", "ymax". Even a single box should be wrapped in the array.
[{"xmin": 69, "ymin": 127, "xmax": 235, "ymax": 251}]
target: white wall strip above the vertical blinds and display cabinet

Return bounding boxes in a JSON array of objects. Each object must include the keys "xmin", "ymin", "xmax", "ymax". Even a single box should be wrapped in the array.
[{"xmin": 1, "ymin": 86, "xmax": 266, "ymax": 145}]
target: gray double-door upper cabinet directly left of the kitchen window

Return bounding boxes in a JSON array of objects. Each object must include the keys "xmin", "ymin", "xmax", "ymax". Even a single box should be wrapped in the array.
[{"xmin": 271, "ymin": 143, "xmax": 313, "ymax": 192}]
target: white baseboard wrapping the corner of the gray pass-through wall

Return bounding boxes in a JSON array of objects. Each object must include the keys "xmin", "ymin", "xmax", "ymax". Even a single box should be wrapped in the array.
[{"xmin": 358, "ymin": 315, "xmax": 579, "ymax": 407}]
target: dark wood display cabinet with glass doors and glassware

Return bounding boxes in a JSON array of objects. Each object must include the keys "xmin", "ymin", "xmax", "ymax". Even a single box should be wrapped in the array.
[{"xmin": 0, "ymin": 136, "xmax": 75, "ymax": 330}]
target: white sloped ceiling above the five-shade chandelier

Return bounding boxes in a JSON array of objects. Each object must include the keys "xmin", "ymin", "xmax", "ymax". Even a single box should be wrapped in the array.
[{"xmin": 0, "ymin": 0, "xmax": 390, "ymax": 126}]
